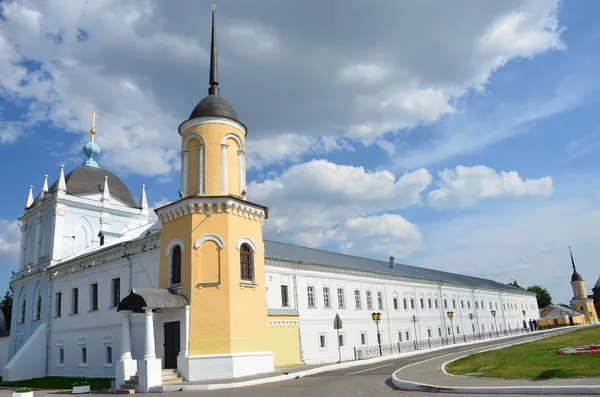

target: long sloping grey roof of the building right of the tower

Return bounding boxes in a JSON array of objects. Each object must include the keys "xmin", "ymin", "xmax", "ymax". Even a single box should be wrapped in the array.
[{"xmin": 265, "ymin": 240, "xmax": 527, "ymax": 293}]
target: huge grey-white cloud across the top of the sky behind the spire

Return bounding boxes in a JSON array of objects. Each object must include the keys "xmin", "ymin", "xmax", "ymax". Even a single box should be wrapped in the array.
[{"xmin": 0, "ymin": 0, "xmax": 564, "ymax": 175}]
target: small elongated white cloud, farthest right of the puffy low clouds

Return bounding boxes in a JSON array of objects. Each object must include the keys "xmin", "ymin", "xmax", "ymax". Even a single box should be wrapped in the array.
[{"xmin": 427, "ymin": 165, "xmax": 553, "ymax": 208}]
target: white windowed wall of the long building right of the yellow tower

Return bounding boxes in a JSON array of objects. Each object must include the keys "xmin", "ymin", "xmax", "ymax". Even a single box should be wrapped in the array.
[{"xmin": 266, "ymin": 265, "xmax": 538, "ymax": 363}]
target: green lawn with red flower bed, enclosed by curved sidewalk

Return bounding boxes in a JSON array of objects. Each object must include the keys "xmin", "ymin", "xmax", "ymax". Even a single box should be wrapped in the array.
[{"xmin": 446, "ymin": 327, "xmax": 600, "ymax": 379}]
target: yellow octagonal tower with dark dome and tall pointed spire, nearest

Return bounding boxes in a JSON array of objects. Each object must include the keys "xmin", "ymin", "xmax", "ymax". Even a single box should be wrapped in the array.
[{"xmin": 156, "ymin": 6, "xmax": 273, "ymax": 381}]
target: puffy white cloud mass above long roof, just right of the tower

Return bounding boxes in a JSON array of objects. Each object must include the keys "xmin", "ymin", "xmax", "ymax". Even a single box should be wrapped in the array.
[{"xmin": 248, "ymin": 160, "xmax": 431, "ymax": 255}]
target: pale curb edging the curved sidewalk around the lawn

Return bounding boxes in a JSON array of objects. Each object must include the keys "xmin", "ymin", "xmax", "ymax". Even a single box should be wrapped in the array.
[{"xmin": 392, "ymin": 328, "xmax": 600, "ymax": 395}]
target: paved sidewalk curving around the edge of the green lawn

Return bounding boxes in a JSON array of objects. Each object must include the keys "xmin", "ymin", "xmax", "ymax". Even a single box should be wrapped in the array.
[{"xmin": 392, "ymin": 332, "xmax": 600, "ymax": 395}]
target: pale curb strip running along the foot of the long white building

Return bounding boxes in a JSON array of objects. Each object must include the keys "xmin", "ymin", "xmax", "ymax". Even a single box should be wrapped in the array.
[{"xmin": 155, "ymin": 330, "xmax": 572, "ymax": 393}]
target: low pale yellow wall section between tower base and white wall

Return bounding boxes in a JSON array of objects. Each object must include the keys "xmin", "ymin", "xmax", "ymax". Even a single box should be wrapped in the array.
[{"xmin": 267, "ymin": 316, "xmax": 300, "ymax": 367}]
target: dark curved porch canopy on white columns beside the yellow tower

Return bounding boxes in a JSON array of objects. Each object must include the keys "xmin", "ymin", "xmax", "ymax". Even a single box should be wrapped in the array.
[{"xmin": 117, "ymin": 288, "xmax": 188, "ymax": 313}]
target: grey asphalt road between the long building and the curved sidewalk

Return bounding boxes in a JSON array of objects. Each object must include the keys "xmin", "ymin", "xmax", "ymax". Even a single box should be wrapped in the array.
[{"xmin": 175, "ymin": 333, "xmax": 572, "ymax": 397}]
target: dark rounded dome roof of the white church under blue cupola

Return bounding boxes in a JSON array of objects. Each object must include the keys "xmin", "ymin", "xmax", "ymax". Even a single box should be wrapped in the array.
[{"xmin": 48, "ymin": 165, "xmax": 138, "ymax": 208}]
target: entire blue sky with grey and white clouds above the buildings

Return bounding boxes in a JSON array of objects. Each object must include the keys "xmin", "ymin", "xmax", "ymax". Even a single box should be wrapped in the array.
[{"xmin": 0, "ymin": 0, "xmax": 600, "ymax": 302}]
